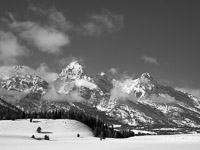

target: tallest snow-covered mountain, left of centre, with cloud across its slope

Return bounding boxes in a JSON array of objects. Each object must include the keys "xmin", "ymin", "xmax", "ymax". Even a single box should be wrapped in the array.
[{"xmin": 55, "ymin": 61, "xmax": 103, "ymax": 99}]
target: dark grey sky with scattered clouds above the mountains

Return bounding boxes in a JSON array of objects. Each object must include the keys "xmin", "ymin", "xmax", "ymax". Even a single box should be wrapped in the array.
[{"xmin": 0, "ymin": 0, "xmax": 200, "ymax": 97}]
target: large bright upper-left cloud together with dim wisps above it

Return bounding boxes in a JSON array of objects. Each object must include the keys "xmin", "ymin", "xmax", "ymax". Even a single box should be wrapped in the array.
[{"xmin": 4, "ymin": 5, "xmax": 72, "ymax": 54}]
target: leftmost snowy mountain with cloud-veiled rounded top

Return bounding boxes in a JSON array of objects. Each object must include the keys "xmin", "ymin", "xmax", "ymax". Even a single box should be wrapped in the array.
[{"xmin": 0, "ymin": 66, "xmax": 48, "ymax": 94}]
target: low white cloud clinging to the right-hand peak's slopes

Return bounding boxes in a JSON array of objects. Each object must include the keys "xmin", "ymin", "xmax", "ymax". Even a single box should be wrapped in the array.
[{"xmin": 111, "ymin": 73, "xmax": 176, "ymax": 104}]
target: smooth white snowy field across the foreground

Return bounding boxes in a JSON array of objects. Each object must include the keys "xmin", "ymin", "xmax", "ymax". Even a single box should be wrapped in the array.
[{"xmin": 0, "ymin": 119, "xmax": 200, "ymax": 150}]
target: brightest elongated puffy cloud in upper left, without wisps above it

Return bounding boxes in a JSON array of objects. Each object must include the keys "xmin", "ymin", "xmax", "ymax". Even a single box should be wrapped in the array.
[{"xmin": 10, "ymin": 21, "xmax": 70, "ymax": 54}]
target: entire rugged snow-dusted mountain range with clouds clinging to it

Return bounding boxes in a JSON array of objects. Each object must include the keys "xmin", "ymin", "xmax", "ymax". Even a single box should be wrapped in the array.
[{"xmin": 0, "ymin": 61, "xmax": 200, "ymax": 128}]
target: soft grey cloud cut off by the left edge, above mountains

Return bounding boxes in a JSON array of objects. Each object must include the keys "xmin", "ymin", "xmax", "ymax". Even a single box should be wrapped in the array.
[{"xmin": 0, "ymin": 30, "xmax": 26, "ymax": 65}]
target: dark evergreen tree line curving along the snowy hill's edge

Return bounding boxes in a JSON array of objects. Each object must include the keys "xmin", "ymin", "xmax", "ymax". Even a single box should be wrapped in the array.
[{"xmin": 0, "ymin": 106, "xmax": 134, "ymax": 138}]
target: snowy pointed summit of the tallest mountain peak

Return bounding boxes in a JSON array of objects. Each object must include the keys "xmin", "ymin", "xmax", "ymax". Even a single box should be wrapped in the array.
[{"xmin": 59, "ymin": 61, "xmax": 85, "ymax": 80}]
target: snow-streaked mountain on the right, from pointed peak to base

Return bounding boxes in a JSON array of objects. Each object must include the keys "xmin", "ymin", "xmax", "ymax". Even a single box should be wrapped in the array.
[{"xmin": 97, "ymin": 73, "xmax": 200, "ymax": 127}]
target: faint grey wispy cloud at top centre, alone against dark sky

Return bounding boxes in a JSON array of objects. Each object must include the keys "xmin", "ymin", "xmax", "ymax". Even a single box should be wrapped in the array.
[{"xmin": 80, "ymin": 10, "xmax": 124, "ymax": 36}]
